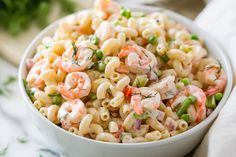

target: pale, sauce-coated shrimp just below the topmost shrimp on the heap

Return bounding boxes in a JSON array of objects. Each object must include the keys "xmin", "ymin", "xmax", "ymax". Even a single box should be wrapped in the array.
[{"xmin": 94, "ymin": 21, "xmax": 116, "ymax": 43}]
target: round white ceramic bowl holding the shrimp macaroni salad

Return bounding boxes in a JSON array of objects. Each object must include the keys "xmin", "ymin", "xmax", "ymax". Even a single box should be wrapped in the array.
[{"xmin": 19, "ymin": 6, "xmax": 233, "ymax": 157}]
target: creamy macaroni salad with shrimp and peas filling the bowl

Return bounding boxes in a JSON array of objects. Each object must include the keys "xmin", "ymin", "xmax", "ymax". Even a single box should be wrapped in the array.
[{"xmin": 24, "ymin": 0, "xmax": 227, "ymax": 143}]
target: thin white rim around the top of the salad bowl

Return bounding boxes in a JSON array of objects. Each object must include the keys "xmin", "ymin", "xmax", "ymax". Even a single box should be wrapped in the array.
[{"xmin": 18, "ymin": 5, "xmax": 233, "ymax": 148}]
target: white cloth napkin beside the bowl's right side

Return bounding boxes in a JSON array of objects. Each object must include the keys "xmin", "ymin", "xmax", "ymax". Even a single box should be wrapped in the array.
[{"xmin": 194, "ymin": 0, "xmax": 236, "ymax": 157}]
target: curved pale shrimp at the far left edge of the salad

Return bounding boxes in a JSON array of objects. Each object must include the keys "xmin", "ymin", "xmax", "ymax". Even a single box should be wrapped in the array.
[{"xmin": 26, "ymin": 59, "xmax": 51, "ymax": 89}]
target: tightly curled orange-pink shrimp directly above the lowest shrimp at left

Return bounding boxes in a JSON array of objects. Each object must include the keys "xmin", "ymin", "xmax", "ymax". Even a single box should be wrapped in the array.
[{"xmin": 58, "ymin": 72, "xmax": 91, "ymax": 100}]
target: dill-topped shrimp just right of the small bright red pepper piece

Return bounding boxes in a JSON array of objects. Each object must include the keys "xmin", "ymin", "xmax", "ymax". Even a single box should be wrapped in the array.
[{"xmin": 131, "ymin": 87, "xmax": 161, "ymax": 115}]
